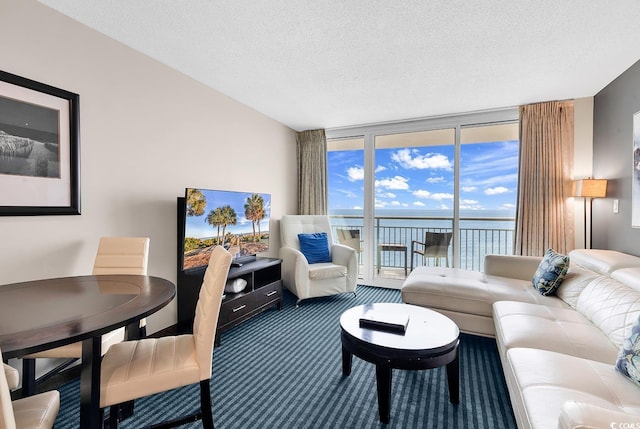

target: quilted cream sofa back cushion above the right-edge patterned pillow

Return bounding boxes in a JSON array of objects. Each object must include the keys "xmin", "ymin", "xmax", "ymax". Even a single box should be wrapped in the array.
[{"xmin": 576, "ymin": 276, "xmax": 640, "ymax": 347}]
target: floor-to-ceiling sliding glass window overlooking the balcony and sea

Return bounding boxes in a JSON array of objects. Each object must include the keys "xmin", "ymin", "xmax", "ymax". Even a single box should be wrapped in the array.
[{"xmin": 327, "ymin": 109, "xmax": 519, "ymax": 286}]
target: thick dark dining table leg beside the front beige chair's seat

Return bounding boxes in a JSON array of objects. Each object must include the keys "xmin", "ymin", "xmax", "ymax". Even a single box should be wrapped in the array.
[{"xmin": 80, "ymin": 336, "xmax": 102, "ymax": 429}]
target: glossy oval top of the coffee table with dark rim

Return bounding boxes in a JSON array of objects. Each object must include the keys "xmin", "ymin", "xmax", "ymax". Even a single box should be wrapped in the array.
[{"xmin": 340, "ymin": 303, "xmax": 460, "ymax": 358}]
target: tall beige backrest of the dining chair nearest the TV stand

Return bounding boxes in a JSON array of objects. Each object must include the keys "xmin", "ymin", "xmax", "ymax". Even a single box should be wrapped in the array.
[{"xmin": 193, "ymin": 246, "xmax": 231, "ymax": 380}]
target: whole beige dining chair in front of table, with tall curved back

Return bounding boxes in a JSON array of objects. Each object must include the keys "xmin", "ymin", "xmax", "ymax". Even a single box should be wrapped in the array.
[{"xmin": 100, "ymin": 246, "xmax": 231, "ymax": 429}]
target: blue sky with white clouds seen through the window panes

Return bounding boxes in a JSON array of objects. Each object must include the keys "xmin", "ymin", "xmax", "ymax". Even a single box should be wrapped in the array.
[{"xmin": 328, "ymin": 141, "xmax": 519, "ymax": 215}]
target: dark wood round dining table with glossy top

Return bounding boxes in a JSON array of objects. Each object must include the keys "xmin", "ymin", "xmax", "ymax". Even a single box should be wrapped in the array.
[{"xmin": 0, "ymin": 275, "xmax": 176, "ymax": 429}]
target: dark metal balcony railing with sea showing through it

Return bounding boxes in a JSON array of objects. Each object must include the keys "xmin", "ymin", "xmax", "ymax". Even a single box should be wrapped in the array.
[{"xmin": 331, "ymin": 216, "xmax": 515, "ymax": 271}]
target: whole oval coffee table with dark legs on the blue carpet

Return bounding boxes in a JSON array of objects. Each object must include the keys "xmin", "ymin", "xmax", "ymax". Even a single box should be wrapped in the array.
[{"xmin": 340, "ymin": 303, "xmax": 460, "ymax": 423}]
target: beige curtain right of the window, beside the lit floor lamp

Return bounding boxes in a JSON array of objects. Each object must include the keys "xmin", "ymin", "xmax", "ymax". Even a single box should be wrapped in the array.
[{"xmin": 514, "ymin": 101, "xmax": 574, "ymax": 256}]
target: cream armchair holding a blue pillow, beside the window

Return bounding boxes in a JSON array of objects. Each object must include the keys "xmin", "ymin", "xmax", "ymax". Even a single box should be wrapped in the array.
[{"xmin": 280, "ymin": 215, "xmax": 358, "ymax": 304}]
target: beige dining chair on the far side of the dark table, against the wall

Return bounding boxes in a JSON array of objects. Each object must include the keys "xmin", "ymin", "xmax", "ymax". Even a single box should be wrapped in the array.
[{"xmin": 22, "ymin": 237, "xmax": 149, "ymax": 396}]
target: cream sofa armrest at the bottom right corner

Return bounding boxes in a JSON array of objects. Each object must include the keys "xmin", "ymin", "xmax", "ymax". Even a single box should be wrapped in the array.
[{"xmin": 558, "ymin": 401, "xmax": 640, "ymax": 429}]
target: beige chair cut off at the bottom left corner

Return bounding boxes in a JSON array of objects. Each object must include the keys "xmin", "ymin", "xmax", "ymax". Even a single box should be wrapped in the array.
[{"xmin": 0, "ymin": 351, "xmax": 60, "ymax": 429}]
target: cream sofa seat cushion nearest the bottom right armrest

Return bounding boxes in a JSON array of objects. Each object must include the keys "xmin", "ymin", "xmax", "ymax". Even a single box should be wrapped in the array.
[{"xmin": 503, "ymin": 348, "xmax": 640, "ymax": 429}]
